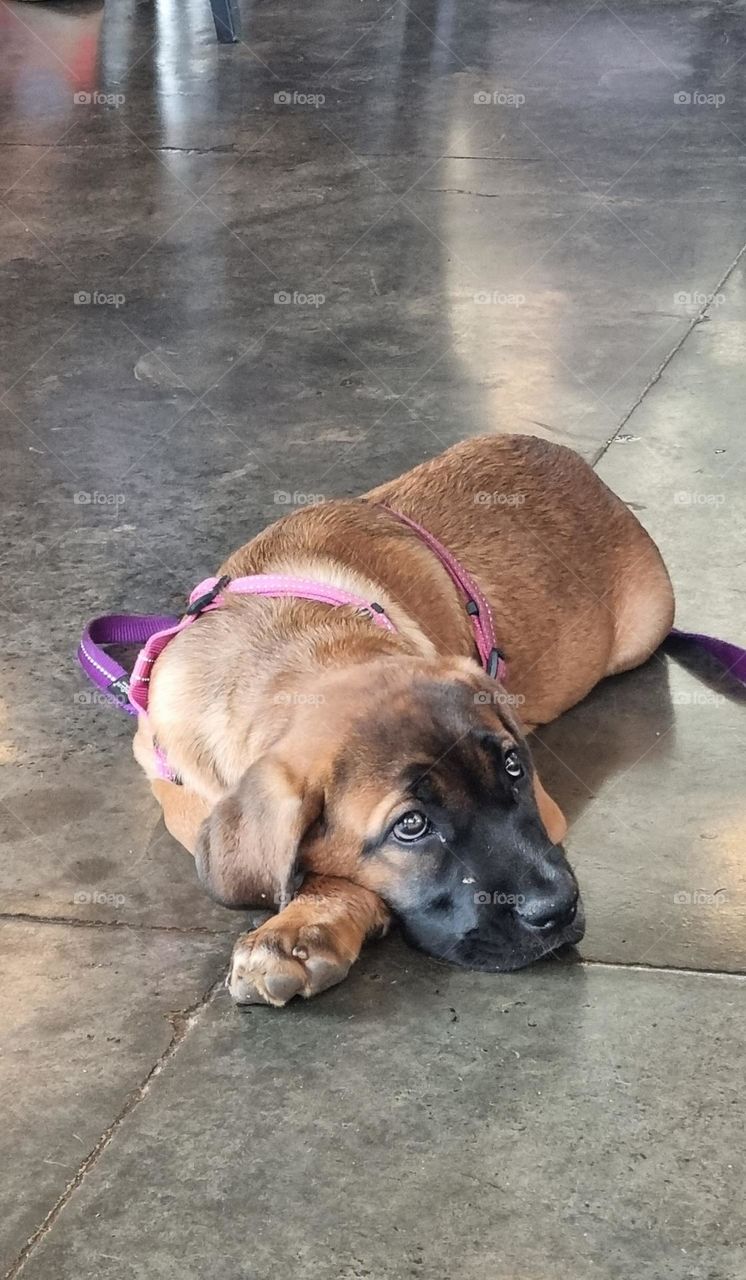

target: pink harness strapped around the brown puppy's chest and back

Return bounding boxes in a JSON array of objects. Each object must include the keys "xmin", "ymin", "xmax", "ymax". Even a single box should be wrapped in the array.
[{"xmin": 78, "ymin": 507, "xmax": 505, "ymax": 782}]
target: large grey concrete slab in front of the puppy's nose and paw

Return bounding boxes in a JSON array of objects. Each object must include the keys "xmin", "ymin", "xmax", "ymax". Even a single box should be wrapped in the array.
[{"xmin": 11, "ymin": 945, "xmax": 746, "ymax": 1280}]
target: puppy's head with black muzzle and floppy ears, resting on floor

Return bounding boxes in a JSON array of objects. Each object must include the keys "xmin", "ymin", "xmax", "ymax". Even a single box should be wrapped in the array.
[{"xmin": 197, "ymin": 659, "xmax": 583, "ymax": 969}]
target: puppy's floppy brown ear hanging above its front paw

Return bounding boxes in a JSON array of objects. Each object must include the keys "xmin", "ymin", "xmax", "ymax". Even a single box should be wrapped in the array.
[{"xmin": 194, "ymin": 753, "xmax": 322, "ymax": 908}]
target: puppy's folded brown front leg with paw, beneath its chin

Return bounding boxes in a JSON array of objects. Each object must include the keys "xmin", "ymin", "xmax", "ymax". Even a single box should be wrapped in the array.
[{"xmin": 228, "ymin": 876, "xmax": 389, "ymax": 1007}]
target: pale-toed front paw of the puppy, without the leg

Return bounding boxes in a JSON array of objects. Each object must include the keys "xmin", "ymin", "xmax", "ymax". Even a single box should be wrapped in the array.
[{"xmin": 225, "ymin": 916, "xmax": 357, "ymax": 1009}]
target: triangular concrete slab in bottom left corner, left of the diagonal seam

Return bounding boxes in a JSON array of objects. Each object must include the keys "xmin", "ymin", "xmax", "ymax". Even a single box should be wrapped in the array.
[{"xmin": 0, "ymin": 919, "xmax": 229, "ymax": 1274}]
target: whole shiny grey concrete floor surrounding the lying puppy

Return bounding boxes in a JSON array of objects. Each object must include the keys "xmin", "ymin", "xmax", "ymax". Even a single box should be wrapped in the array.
[{"xmin": 0, "ymin": 0, "xmax": 746, "ymax": 1280}]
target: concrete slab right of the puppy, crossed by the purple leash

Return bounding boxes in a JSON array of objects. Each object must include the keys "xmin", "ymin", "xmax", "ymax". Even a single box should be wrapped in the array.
[{"xmin": 539, "ymin": 266, "xmax": 746, "ymax": 973}]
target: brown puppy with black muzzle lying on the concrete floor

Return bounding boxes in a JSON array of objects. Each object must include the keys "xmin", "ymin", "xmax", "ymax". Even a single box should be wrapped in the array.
[{"xmin": 134, "ymin": 435, "xmax": 673, "ymax": 1005}]
